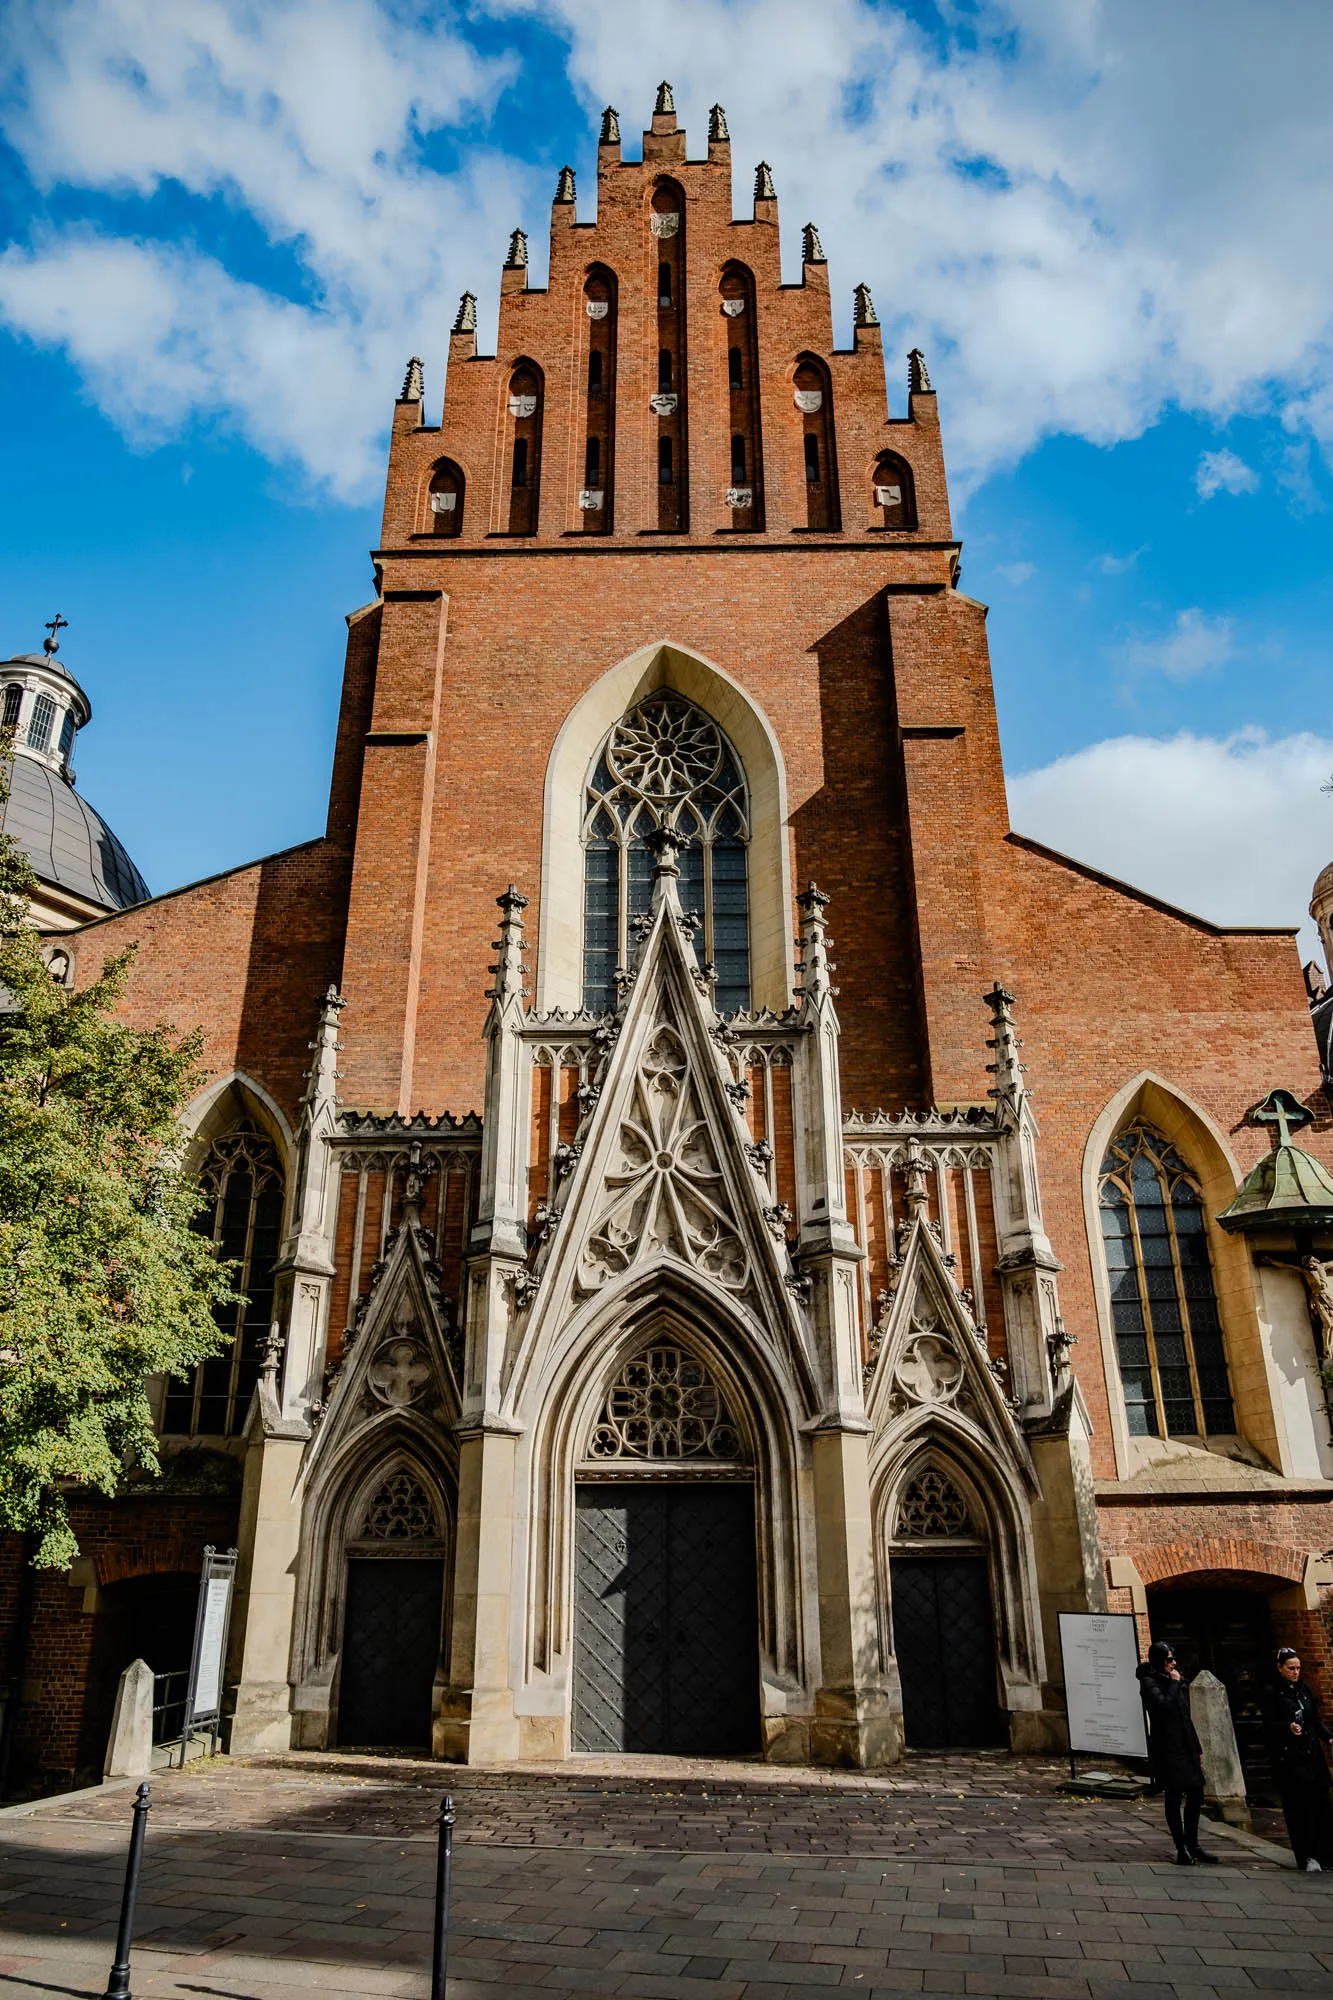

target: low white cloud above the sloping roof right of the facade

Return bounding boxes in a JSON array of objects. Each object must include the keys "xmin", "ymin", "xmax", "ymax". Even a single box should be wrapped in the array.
[{"xmin": 1009, "ymin": 730, "xmax": 1333, "ymax": 958}]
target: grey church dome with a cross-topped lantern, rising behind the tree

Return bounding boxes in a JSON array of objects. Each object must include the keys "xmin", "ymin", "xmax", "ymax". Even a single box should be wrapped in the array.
[{"xmin": 0, "ymin": 620, "xmax": 148, "ymax": 924}]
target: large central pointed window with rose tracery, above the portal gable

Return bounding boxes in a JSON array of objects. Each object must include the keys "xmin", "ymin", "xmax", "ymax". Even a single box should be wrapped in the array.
[{"xmin": 582, "ymin": 690, "xmax": 751, "ymax": 1014}]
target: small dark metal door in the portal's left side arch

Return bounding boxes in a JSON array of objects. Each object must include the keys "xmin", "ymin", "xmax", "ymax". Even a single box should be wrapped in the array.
[{"xmin": 338, "ymin": 1556, "xmax": 444, "ymax": 1750}]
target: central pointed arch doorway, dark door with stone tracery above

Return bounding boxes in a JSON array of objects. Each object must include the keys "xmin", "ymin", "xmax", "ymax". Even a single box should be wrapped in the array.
[{"xmin": 572, "ymin": 1340, "xmax": 759, "ymax": 1756}]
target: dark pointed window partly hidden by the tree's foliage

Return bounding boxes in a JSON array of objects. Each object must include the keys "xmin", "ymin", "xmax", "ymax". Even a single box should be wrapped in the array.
[{"xmin": 162, "ymin": 1120, "xmax": 286, "ymax": 1438}]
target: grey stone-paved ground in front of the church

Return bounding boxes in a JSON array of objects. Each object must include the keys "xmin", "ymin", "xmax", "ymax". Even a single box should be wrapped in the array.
[{"xmin": 0, "ymin": 1756, "xmax": 1333, "ymax": 2000}]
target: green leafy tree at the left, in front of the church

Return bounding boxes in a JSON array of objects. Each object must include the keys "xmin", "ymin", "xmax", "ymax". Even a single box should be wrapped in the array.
[{"xmin": 0, "ymin": 742, "xmax": 234, "ymax": 1568}]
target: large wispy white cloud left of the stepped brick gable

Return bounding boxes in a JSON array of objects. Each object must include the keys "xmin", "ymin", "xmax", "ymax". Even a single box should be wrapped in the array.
[{"xmin": 0, "ymin": 0, "xmax": 532, "ymax": 498}]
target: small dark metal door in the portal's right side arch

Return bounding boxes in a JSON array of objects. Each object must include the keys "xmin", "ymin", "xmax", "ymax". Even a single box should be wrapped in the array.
[{"xmin": 891, "ymin": 1556, "xmax": 1003, "ymax": 1750}]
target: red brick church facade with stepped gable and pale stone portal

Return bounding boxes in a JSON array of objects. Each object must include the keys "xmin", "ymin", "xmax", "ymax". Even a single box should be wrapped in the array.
[{"xmin": 6, "ymin": 92, "xmax": 1333, "ymax": 1778}]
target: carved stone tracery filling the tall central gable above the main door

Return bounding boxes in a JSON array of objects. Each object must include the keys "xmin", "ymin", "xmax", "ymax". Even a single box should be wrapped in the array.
[{"xmin": 578, "ymin": 1026, "xmax": 751, "ymax": 1294}]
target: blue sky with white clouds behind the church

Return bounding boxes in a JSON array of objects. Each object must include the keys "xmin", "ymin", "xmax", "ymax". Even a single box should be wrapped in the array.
[{"xmin": 0, "ymin": 0, "xmax": 1333, "ymax": 954}]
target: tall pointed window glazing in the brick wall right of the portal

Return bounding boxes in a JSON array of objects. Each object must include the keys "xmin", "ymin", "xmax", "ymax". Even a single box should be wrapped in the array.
[{"xmin": 1101, "ymin": 1120, "xmax": 1235, "ymax": 1438}]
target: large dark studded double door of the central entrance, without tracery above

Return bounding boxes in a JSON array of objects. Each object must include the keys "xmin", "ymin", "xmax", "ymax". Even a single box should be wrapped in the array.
[{"xmin": 574, "ymin": 1480, "xmax": 759, "ymax": 1756}]
